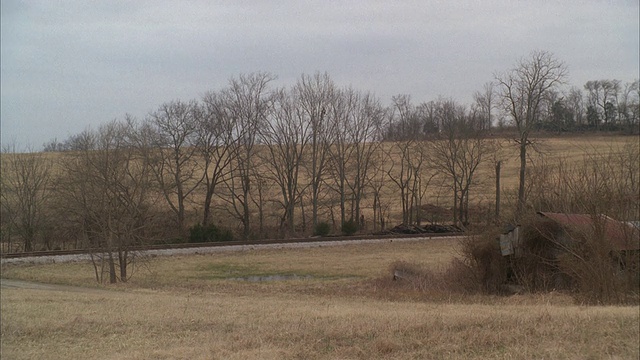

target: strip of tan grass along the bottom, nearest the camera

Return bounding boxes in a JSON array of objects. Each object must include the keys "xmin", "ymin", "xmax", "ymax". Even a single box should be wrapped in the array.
[{"xmin": 2, "ymin": 290, "xmax": 639, "ymax": 359}]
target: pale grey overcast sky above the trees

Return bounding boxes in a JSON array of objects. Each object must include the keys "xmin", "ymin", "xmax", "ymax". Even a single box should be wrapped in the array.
[{"xmin": 0, "ymin": 0, "xmax": 640, "ymax": 149}]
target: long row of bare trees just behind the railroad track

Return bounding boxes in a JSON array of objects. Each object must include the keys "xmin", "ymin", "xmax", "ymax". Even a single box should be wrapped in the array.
[{"xmin": 3, "ymin": 73, "xmax": 492, "ymax": 245}]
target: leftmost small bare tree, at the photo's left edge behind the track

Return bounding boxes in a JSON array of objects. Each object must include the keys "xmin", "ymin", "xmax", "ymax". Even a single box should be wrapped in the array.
[{"xmin": 0, "ymin": 144, "xmax": 53, "ymax": 251}]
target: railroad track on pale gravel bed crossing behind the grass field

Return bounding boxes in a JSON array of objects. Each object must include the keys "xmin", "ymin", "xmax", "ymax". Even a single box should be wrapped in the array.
[{"xmin": 0, "ymin": 233, "xmax": 462, "ymax": 259}]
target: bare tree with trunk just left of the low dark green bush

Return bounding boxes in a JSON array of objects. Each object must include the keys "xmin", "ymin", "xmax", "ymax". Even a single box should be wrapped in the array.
[{"xmin": 147, "ymin": 101, "xmax": 204, "ymax": 236}]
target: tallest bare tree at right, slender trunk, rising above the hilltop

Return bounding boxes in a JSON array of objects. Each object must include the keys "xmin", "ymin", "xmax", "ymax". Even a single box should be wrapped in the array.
[{"xmin": 496, "ymin": 51, "xmax": 567, "ymax": 214}]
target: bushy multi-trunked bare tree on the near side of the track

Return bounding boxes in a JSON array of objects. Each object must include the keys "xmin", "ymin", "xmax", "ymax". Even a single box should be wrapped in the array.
[{"xmin": 59, "ymin": 121, "xmax": 153, "ymax": 283}]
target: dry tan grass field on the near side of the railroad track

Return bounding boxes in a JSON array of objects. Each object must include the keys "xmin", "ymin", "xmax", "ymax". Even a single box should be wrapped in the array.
[{"xmin": 0, "ymin": 239, "xmax": 640, "ymax": 359}]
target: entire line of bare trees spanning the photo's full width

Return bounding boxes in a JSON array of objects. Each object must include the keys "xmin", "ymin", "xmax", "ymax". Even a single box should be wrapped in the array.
[{"xmin": 1, "ymin": 51, "xmax": 639, "ymax": 282}]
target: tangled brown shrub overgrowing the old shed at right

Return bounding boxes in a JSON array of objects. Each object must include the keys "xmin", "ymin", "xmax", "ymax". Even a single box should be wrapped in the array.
[{"xmin": 510, "ymin": 216, "xmax": 640, "ymax": 304}]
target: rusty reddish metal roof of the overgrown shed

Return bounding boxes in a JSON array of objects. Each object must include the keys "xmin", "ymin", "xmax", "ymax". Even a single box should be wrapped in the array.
[{"xmin": 538, "ymin": 211, "xmax": 640, "ymax": 251}]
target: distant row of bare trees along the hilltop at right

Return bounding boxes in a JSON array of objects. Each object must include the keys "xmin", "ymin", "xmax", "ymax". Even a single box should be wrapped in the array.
[{"xmin": 383, "ymin": 81, "xmax": 640, "ymax": 141}]
